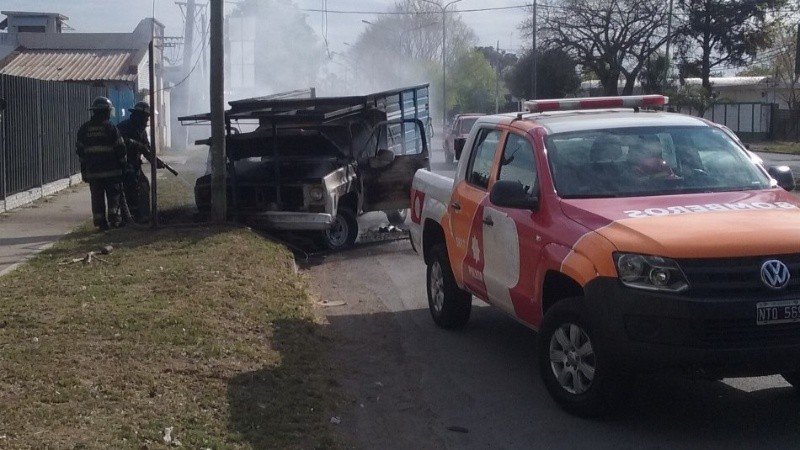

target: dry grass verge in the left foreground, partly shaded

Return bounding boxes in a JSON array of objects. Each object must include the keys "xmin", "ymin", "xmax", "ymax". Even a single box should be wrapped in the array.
[{"xmin": 0, "ymin": 174, "xmax": 340, "ymax": 449}]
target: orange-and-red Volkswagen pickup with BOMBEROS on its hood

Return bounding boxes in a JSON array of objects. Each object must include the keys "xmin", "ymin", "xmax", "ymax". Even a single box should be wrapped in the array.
[{"xmin": 411, "ymin": 95, "xmax": 800, "ymax": 416}]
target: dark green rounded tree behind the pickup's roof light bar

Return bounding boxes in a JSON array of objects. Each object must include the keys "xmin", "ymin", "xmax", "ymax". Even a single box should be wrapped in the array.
[{"xmin": 506, "ymin": 49, "xmax": 581, "ymax": 99}]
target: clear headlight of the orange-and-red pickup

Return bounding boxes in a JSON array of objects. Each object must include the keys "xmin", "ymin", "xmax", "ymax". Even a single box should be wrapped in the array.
[{"xmin": 614, "ymin": 253, "xmax": 689, "ymax": 292}]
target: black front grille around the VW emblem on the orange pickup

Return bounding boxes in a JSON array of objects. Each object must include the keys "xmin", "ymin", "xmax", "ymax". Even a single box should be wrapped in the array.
[{"xmin": 678, "ymin": 255, "xmax": 800, "ymax": 298}]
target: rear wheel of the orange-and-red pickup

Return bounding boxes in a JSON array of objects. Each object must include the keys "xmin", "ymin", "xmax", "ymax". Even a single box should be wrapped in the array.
[{"xmin": 427, "ymin": 244, "xmax": 472, "ymax": 329}]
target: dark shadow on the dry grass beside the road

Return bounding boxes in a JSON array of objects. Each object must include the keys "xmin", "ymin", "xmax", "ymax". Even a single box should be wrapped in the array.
[{"xmin": 227, "ymin": 320, "xmax": 336, "ymax": 449}]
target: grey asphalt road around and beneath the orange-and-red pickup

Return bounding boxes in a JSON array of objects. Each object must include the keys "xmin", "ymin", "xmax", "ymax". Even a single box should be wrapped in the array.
[{"xmin": 306, "ymin": 146, "xmax": 800, "ymax": 449}]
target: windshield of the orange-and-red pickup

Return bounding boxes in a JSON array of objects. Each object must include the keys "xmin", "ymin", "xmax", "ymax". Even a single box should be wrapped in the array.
[{"xmin": 545, "ymin": 127, "xmax": 770, "ymax": 198}]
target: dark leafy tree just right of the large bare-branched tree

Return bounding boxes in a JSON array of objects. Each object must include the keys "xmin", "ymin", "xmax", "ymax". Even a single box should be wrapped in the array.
[{"xmin": 678, "ymin": 0, "xmax": 785, "ymax": 97}]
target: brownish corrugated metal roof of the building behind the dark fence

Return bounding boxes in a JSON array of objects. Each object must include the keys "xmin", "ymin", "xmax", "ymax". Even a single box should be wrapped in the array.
[{"xmin": 0, "ymin": 49, "xmax": 137, "ymax": 81}]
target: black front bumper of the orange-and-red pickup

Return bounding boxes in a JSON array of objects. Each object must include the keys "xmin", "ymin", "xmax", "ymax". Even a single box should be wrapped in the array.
[{"xmin": 586, "ymin": 278, "xmax": 800, "ymax": 376}]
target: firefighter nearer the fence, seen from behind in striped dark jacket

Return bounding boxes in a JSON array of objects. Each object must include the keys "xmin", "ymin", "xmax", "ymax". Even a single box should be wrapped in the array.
[{"xmin": 75, "ymin": 97, "xmax": 125, "ymax": 230}]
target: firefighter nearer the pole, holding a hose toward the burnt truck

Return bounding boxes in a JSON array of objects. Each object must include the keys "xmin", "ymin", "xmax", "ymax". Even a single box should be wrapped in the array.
[{"xmin": 119, "ymin": 102, "xmax": 160, "ymax": 222}]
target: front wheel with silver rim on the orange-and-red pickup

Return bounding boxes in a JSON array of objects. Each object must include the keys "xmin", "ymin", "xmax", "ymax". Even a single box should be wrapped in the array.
[{"xmin": 537, "ymin": 298, "xmax": 620, "ymax": 417}]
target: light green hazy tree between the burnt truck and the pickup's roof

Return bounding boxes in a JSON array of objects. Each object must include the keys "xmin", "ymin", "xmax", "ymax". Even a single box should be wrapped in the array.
[{"xmin": 447, "ymin": 50, "xmax": 496, "ymax": 116}]
